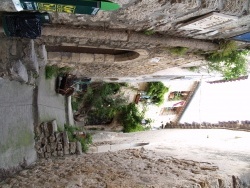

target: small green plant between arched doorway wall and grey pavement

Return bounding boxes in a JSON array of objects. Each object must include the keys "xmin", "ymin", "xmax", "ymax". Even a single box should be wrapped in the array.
[{"xmin": 45, "ymin": 65, "xmax": 71, "ymax": 79}]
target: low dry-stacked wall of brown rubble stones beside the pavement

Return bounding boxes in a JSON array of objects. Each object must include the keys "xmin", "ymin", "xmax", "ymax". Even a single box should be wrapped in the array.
[{"xmin": 35, "ymin": 120, "xmax": 82, "ymax": 159}]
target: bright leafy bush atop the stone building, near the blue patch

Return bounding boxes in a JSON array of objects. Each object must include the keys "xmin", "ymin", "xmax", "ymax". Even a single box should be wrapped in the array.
[{"xmin": 206, "ymin": 41, "xmax": 249, "ymax": 80}]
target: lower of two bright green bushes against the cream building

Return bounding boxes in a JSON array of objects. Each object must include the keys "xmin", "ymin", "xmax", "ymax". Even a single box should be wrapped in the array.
[{"xmin": 119, "ymin": 103, "xmax": 146, "ymax": 133}]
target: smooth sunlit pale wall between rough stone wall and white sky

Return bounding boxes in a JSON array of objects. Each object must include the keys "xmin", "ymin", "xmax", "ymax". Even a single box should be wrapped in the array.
[{"xmin": 91, "ymin": 129, "xmax": 250, "ymax": 185}]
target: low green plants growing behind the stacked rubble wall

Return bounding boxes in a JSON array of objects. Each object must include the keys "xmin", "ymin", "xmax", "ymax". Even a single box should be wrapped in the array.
[{"xmin": 64, "ymin": 124, "xmax": 92, "ymax": 152}]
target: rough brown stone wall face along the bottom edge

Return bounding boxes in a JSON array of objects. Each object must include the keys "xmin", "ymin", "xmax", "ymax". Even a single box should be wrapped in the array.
[{"xmin": 0, "ymin": 148, "xmax": 240, "ymax": 188}]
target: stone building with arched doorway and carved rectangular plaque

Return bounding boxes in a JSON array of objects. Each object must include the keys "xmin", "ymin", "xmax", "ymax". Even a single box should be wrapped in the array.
[{"xmin": 1, "ymin": 0, "xmax": 250, "ymax": 81}]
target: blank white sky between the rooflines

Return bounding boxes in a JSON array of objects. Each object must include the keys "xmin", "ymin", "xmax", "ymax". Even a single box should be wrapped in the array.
[{"xmin": 180, "ymin": 76, "xmax": 250, "ymax": 123}]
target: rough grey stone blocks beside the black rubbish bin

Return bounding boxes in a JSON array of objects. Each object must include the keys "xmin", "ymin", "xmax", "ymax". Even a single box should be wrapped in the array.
[{"xmin": 0, "ymin": 36, "xmax": 46, "ymax": 85}]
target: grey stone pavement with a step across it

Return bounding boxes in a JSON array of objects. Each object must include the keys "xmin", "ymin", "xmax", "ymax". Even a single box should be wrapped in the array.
[{"xmin": 0, "ymin": 68, "xmax": 66, "ymax": 180}]
